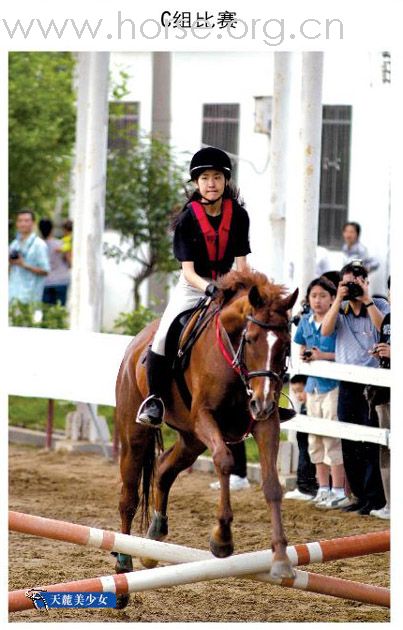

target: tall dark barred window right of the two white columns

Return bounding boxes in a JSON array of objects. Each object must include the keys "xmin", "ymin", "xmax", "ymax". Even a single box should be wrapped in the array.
[{"xmin": 318, "ymin": 105, "xmax": 351, "ymax": 249}]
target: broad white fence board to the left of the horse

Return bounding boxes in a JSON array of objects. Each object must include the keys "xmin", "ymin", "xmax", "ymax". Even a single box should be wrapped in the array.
[{"xmin": 5, "ymin": 327, "xmax": 132, "ymax": 406}]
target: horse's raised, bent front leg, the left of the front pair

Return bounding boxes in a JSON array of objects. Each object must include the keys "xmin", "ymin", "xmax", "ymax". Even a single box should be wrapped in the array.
[{"xmin": 195, "ymin": 408, "xmax": 234, "ymax": 558}]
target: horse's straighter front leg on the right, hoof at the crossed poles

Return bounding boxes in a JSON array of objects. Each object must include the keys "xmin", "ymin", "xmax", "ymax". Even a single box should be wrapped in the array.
[{"xmin": 253, "ymin": 414, "xmax": 295, "ymax": 578}]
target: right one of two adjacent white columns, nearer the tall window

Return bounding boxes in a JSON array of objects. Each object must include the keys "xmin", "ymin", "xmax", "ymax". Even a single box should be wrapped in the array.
[{"xmin": 295, "ymin": 52, "xmax": 323, "ymax": 298}]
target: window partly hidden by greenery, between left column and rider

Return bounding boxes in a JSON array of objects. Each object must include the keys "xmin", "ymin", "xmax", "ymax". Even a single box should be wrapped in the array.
[{"xmin": 108, "ymin": 101, "xmax": 140, "ymax": 151}]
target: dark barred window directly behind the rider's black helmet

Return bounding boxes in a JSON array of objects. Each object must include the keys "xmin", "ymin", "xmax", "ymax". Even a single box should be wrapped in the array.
[{"xmin": 202, "ymin": 103, "xmax": 240, "ymax": 181}]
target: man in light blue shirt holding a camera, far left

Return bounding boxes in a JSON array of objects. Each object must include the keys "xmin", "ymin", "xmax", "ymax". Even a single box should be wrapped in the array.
[{"xmin": 8, "ymin": 210, "xmax": 50, "ymax": 304}]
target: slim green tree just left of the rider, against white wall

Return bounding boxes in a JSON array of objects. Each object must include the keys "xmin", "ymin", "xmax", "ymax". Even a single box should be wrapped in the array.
[{"xmin": 105, "ymin": 137, "xmax": 183, "ymax": 309}]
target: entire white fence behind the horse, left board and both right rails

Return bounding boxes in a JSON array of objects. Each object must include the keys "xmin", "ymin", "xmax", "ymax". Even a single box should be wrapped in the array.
[{"xmin": 5, "ymin": 327, "xmax": 391, "ymax": 445}]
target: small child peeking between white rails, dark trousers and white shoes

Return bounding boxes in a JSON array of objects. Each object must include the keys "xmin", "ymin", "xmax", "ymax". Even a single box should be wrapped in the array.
[{"xmin": 284, "ymin": 374, "xmax": 318, "ymax": 501}]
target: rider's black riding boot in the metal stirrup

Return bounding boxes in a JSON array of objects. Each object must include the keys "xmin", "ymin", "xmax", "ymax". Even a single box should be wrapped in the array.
[{"xmin": 136, "ymin": 348, "xmax": 172, "ymax": 429}]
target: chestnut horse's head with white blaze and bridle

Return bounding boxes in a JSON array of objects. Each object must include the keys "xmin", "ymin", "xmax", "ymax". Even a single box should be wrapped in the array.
[{"xmin": 243, "ymin": 283, "xmax": 298, "ymax": 420}]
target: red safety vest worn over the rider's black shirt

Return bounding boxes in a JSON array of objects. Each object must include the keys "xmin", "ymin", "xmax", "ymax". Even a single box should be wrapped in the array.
[{"xmin": 190, "ymin": 199, "xmax": 232, "ymax": 280}]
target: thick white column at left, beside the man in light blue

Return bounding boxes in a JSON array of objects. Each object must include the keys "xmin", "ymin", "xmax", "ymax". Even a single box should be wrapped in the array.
[{"xmin": 70, "ymin": 52, "xmax": 109, "ymax": 331}]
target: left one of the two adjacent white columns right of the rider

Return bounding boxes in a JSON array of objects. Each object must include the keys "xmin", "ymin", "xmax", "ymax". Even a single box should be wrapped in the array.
[{"xmin": 267, "ymin": 52, "xmax": 293, "ymax": 283}]
